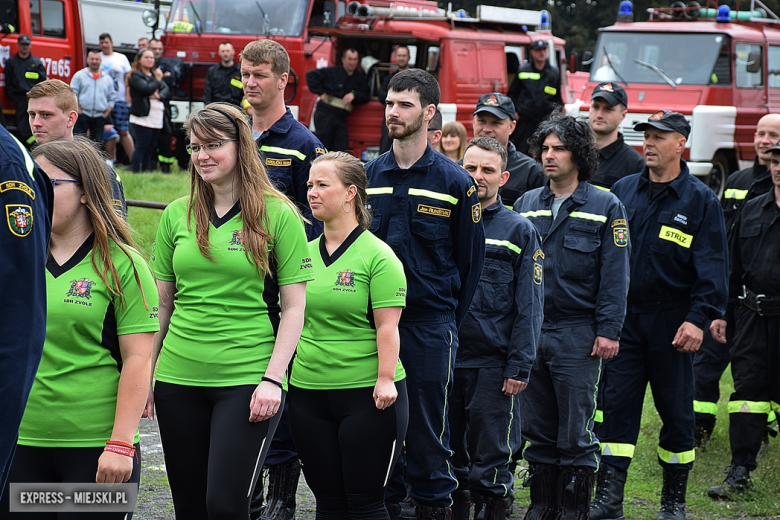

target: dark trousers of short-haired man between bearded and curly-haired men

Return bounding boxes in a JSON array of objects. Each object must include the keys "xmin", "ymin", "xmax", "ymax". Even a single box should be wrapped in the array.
[{"xmin": 450, "ymin": 367, "xmax": 520, "ymax": 497}]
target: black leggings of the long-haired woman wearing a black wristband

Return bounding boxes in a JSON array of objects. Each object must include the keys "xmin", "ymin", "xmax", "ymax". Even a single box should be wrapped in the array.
[{"xmin": 154, "ymin": 381, "xmax": 285, "ymax": 520}]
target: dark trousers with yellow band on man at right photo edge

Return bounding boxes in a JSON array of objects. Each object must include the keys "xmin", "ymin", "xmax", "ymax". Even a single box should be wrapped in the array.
[{"xmin": 728, "ymin": 307, "xmax": 780, "ymax": 471}]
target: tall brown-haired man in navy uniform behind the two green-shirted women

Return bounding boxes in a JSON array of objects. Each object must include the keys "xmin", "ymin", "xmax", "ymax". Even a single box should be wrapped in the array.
[{"xmin": 241, "ymin": 40, "xmax": 325, "ymax": 520}]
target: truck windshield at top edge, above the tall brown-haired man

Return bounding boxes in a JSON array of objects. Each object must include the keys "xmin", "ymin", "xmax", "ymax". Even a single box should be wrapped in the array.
[{"xmin": 168, "ymin": 0, "xmax": 309, "ymax": 36}]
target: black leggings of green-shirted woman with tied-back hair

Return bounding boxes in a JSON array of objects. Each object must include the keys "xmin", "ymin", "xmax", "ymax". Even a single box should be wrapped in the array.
[{"xmin": 290, "ymin": 380, "xmax": 409, "ymax": 520}]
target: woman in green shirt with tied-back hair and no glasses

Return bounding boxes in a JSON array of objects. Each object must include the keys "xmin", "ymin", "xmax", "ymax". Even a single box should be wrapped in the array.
[{"xmin": 290, "ymin": 152, "xmax": 409, "ymax": 520}]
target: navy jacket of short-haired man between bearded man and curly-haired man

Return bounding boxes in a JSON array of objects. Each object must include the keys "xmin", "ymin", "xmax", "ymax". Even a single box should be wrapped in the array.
[{"xmin": 455, "ymin": 197, "xmax": 544, "ymax": 383}]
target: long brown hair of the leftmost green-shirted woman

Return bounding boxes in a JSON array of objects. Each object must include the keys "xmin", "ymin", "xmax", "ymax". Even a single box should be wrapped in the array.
[{"xmin": 32, "ymin": 136, "xmax": 149, "ymax": 309}]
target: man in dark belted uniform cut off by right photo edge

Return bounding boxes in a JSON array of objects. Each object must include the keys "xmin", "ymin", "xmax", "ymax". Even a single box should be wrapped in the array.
[{"xmin": 707, "ymin": 141, "xmax": 780, "ymax": 498}]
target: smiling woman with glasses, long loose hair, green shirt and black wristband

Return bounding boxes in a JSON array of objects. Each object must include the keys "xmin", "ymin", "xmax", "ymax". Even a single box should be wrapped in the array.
[{"xmin": 147, "ymin": 103, "xmax": 313, "ymax": 520}]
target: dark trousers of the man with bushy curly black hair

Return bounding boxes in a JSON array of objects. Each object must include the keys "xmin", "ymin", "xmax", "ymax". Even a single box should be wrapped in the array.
[{"xmin": 519, "ymin": 325, "xmax": 601, "ymax": 470}]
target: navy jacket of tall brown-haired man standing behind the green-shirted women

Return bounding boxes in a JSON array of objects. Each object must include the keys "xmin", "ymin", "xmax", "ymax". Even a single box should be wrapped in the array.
[{"xmin": 249, "ymin": 108, "xmax": 325, "ymax": 240}]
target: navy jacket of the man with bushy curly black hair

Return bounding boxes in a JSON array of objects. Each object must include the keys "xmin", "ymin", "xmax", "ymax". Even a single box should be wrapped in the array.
[{"xmin": 514, "ymin": 182, "xmax": 630, "ymax": 339}]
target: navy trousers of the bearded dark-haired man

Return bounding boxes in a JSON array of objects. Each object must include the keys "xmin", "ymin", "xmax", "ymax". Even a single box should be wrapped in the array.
[{"xmin": 385, "ymin": 320, "xmax": 458, "ymax": 507}]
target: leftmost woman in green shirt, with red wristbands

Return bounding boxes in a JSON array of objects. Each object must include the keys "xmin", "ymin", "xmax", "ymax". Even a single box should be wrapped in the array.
[{"xmin": 0, "ymin": 136, "xmax": 159, "ymax": 520}]
